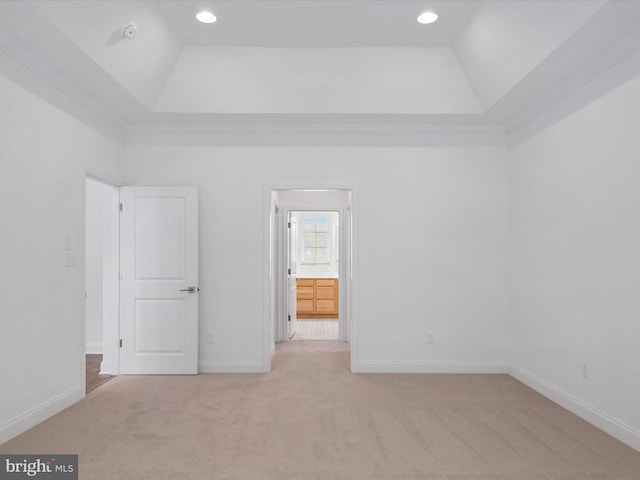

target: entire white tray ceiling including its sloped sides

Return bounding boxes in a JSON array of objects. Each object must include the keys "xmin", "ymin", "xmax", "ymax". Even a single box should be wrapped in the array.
[{"xmin": 0, "ymin": 0, "xmax": 640, "ymax": 135}]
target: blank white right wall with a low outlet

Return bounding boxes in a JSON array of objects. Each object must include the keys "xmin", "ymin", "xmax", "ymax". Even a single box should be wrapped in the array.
[{"xmin": 510, "ymin": 72, "xmax": 640, "ymax": 449}]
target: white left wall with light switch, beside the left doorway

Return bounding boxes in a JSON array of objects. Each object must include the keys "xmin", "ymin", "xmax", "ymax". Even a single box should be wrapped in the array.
[{"xmin": 0, "ymin": 49, "xmax": 123, "ymax": 443}]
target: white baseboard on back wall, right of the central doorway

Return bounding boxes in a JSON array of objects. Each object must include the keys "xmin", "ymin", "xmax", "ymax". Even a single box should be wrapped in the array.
[{"xmin": 354, "ymin": 361, "xmax": 509, "ymax": 373}]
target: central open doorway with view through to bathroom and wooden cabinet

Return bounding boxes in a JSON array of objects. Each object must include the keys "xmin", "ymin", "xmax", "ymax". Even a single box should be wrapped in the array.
[{"xmin": 267, "ymin": 188, "xmax": 354, "ymax": 364}]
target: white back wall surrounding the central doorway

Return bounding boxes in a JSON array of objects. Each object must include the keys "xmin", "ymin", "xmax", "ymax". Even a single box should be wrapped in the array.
[{"xmin": 125, "ymin": 140, "xmax": 507, "ymax": 371}]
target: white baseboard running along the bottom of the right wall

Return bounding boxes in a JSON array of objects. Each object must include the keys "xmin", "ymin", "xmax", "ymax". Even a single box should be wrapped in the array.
[{"xmin": 508, "ymin": 364, "xmax": 640, "ymax": 451}]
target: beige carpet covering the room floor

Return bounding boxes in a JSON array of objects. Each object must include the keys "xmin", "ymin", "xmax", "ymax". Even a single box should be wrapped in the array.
[{"xmin": 0, "ymin": 342, "xmax": 640, "ymax": 480}]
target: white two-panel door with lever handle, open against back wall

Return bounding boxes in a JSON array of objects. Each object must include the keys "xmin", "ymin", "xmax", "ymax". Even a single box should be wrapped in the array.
[{"xmin": 120, "ymin": 187, "xmax": 199, "ymax": 374}]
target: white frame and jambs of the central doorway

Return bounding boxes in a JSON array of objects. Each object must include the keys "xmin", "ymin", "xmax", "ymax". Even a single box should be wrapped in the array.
[{"xmin": 264, "ymin": 185, "xmax": 358, "ymax": 372}]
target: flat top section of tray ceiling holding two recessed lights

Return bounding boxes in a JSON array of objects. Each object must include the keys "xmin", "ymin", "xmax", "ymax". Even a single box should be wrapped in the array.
[{"xmin": 160, "ymin": 0, "xmax": 477, "ymax": 48}]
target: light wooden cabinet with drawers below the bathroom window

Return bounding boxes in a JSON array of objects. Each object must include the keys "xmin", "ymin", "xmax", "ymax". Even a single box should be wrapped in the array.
[{"xmin": 296, "ymin": 278, "xmax": 338, "ymax": 318}]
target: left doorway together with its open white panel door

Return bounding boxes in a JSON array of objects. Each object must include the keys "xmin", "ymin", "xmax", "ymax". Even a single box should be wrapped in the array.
[{"xmin": 82, "ymin": 182, "xmax": 200, "ymax": 375}]
